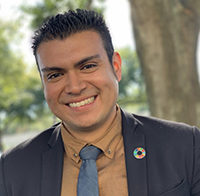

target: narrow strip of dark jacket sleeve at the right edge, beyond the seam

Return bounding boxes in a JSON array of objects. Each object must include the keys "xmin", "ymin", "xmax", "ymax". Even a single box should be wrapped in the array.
[{"xmin": 191, "ymin": 127, "xmax": 200, "ymax": 196}]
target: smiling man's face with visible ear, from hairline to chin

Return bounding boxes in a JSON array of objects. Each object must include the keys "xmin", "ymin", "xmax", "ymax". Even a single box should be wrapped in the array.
[{"xmin": 37, "ymin": 31, "xmax": 121, "ymax": 135}]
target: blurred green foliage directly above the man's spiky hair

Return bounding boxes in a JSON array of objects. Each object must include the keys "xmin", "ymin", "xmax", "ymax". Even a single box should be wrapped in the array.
[{"xmin": 21, "ymin": 0, "xmax": 105, "ymax": 29}]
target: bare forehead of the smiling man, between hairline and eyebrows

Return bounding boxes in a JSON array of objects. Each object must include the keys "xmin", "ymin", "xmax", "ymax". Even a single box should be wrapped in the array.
[{"xmin": 37, "ymin": 31, "xmax": 106, "ymax": 65}]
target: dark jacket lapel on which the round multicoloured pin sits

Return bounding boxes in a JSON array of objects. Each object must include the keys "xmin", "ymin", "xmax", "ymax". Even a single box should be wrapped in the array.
[{"xmin": 122, "ymin": 111, "xmax": 148, "ymax": 196}]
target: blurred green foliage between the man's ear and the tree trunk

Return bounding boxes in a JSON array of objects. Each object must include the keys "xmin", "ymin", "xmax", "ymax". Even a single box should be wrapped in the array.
[{"xmin": 118, "ymin": 47, "xmax": 147, "ymax": 105}]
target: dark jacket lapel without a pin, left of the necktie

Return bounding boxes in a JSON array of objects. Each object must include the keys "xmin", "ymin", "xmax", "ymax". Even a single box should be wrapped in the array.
[{"xmin": 41, "ymin": 126, "xmax": 63, "ymax": 196}]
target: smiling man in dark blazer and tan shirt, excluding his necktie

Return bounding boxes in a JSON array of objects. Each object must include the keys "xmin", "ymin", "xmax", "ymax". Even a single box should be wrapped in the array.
[{"xmin": 0, "ymin": 10, "xmax": 200, "ymax": 196}]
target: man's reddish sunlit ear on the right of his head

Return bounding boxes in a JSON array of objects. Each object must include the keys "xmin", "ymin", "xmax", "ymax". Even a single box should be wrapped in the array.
[{"xmin": 113, "ymin": 52, "xmax": 122, "ymax": 82}]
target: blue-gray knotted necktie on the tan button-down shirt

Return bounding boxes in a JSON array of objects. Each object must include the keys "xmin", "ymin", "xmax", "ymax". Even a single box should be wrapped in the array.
[{"xmin": 77, "ymin": 146, "xmax": 101, "ymax": 196}]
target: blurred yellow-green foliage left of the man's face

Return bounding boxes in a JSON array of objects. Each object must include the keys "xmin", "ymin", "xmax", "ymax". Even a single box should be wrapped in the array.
[{"xmin": 0, "ymin": 21, "xmax": 46, "ymax": 150}]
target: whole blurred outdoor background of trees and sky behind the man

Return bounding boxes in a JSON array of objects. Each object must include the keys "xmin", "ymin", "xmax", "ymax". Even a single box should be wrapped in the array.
[{"xmin": 0, "ymin": 0, "xmax": 200, "ymax": 152}]
